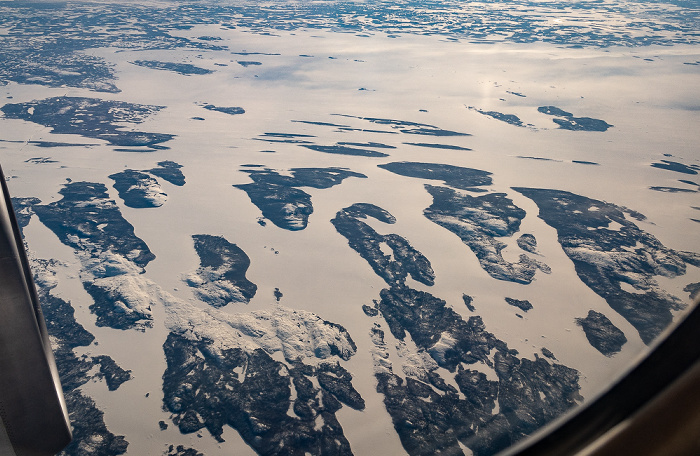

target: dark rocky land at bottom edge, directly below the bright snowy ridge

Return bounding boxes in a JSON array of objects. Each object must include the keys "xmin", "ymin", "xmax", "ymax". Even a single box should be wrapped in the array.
[{"xmin": 163, "ymin": 326, "xmax": 365, "ymax": 456}]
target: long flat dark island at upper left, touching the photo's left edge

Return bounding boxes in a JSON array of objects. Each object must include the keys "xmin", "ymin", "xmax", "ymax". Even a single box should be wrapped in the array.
[{"xmin": 0, "ymin": 97, "xmax": 175, "ymax": 148}]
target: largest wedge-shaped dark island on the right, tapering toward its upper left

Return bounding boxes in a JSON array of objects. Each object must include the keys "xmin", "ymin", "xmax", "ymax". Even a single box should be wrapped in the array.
[{"xmin": 513, "ymin": 187, "xmax": 700, "ymax": 344}]
